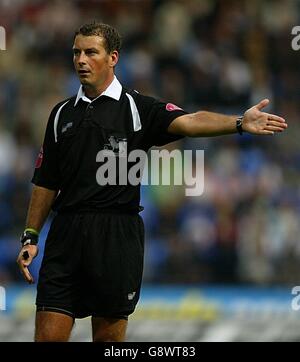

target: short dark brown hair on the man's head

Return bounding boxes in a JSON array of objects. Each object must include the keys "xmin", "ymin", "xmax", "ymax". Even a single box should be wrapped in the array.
[{"xmin": 74, "ymin": 21, "xmax": 122, "ymax": 54}]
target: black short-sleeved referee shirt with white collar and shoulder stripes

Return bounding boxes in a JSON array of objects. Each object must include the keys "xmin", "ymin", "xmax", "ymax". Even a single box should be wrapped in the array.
[{"xmin": 32, "ymin": 77, "xmax": 186, "ymax": 212}]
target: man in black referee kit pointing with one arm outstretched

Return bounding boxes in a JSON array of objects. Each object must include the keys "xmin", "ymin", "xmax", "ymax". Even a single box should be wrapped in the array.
[{"xmin": 17, "ymin": 23, "xmax": 287, "ymax": 341}]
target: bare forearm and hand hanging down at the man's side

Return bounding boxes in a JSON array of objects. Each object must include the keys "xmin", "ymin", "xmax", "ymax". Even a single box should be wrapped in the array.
[{"xmin": 17, "ymin": 186, "xmax": 57, "ymax": 284}]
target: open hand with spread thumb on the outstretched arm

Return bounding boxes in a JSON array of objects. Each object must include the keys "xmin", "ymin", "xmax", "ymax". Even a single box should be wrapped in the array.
[{"xmin": 243, "ymin": 99, "xmax": 287, "ymax": 135}]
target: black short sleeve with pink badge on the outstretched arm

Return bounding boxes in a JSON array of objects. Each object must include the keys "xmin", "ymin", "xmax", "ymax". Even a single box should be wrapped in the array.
[{"xmin": 137, "ymin": 96, "xmax": 187, "ymax": 147}]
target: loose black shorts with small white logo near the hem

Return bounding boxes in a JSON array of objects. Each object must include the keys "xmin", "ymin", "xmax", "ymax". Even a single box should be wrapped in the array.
[{"xmin": 36, "ymin": 212, "xmax": 144, "ymax": 319}]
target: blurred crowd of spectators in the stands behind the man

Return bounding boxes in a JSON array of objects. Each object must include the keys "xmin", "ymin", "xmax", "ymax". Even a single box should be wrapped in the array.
[{"xmin": 0, "ymin": 0, "xmax": 300, "ymax": 285}]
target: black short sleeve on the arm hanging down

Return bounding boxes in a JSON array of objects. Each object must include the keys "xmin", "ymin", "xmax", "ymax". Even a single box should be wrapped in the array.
[{"xmin": 31, "ymin": 106, "xmax": 59, "ymax": 190}]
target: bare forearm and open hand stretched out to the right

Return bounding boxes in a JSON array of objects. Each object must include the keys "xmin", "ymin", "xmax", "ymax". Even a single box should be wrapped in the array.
[{"xmin": 168, "ymin": 99, "xmax": 287, "ymax": 137}]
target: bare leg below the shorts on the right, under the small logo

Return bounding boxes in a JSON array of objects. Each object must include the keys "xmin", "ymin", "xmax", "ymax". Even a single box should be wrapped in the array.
[{"xmin": 92, "ymin": 317, "xmax": 128, "ymax": 342}]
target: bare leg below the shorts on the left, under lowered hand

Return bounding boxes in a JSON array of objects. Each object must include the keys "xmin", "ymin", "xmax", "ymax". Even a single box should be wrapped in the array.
[{"xmin": 34, "ymin": 312, "xmax": 74, "ymax": 342}]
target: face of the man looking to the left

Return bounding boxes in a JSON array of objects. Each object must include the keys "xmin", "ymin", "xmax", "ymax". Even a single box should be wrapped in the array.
[{"xmin": 73, "ymin": 34, "xmax": 118, "ymax": 91}]
